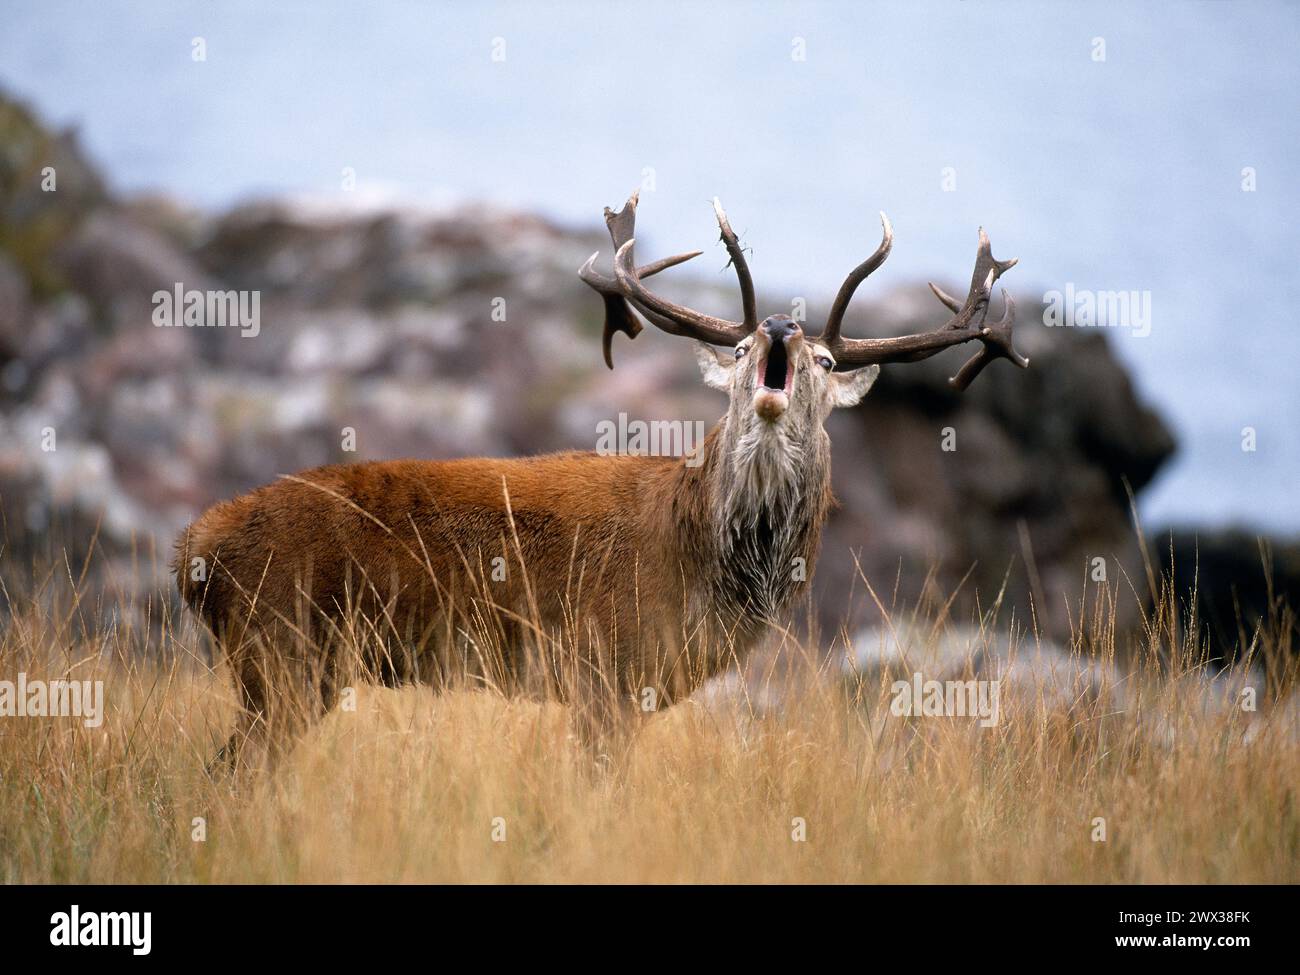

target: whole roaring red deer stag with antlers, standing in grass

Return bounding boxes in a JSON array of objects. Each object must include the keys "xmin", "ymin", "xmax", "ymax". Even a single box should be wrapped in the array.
[{"xmin": 176, "ymin": 195, "xmax": 1028, "ymax": 764}]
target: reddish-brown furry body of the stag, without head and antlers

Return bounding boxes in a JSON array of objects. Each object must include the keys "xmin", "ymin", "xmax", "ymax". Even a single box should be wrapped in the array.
[{"xmin": 176, "ymin": 420, "xmax": 831, "ymax": 761}]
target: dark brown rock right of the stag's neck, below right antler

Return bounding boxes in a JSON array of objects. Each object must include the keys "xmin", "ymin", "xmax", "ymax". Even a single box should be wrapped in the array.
[{"xmin": 823, "ymin": 298, "xmax": 1174, "ymax": 636}]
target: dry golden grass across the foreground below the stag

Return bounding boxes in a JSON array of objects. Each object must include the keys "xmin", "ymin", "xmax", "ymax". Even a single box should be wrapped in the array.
[{"xmin": 0, "ymin": 546, "xmax": 1300, "ymax": 883}]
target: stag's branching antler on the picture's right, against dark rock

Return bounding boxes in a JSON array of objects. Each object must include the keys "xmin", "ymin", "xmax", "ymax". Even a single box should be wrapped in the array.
[{"xmin": 818, "ymin": 213, "xmax": 1030, "ymax": 390}]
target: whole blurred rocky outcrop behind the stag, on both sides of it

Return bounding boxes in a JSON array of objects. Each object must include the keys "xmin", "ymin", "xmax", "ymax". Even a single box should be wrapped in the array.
[{"xmin": 0, "ymin": 91, "xmax": 1196, "ymax": 650}]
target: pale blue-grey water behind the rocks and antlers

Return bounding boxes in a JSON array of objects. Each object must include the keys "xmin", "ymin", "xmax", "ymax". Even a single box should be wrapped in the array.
[{"xmin": 0, "ymin": 0, "xmax": 1300, "ymax": 533}]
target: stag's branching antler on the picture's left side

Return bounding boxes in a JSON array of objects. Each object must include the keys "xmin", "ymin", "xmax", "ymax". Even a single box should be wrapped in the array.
[{"xmin": 579, "ymin": 192, "xmax": 758, "ymax": 369}]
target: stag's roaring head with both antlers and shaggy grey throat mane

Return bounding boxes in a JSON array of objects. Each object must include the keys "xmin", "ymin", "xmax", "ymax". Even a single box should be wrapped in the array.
[{"xmin": 579, "ymin": 194, "xmax": 1028, "ymax": 620}]
